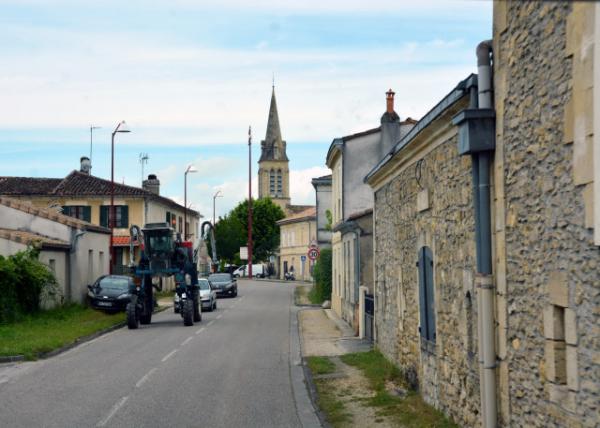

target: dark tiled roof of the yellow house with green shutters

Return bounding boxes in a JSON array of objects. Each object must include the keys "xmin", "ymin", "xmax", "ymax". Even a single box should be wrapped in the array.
[{"xmin": 0, "ymin": 170, "xmax": 200, "ymax": 216}]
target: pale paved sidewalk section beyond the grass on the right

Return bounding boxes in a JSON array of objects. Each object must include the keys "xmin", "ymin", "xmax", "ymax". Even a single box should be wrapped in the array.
[{"xmin": 298, "ymin": 308, "xmax": 372, "ymax": 357}]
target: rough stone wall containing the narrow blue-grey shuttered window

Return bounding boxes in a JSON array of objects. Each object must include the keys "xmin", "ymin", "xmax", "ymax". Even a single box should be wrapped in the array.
[{"xmin": 374, "ymin": 132, "xmax": 480, "ymax": 426}]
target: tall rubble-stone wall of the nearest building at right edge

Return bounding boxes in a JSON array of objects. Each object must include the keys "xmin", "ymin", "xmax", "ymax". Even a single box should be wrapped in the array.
[{"xmin": 494, "ymin": 1, "xmax": 600, "ymax": 427}]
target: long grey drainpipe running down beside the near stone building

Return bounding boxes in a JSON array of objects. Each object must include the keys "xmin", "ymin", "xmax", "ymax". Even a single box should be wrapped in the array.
[{"xmin": 473, "ymin": 40, "xmax": 497, "ymax": 428}]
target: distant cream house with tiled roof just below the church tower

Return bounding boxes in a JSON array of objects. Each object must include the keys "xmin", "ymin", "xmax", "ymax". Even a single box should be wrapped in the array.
[{"xmin": 277, "ymin": 206, "xmax": 317, "ymax": 281}]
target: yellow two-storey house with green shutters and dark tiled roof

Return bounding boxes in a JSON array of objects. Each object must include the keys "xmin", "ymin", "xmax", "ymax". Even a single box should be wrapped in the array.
[{"xmin": 0, "ymin": 157, "xmax": 202, "ymax": 272}]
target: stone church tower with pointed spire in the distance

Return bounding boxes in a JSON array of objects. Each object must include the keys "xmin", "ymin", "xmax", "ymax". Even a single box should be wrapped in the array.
[{"xmin": 258, "ymin": 86, "xmax": 290, "ymax": 213}]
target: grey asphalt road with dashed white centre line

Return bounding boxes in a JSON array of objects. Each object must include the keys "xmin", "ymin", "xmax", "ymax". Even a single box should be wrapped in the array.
[{"xmin": 0, "ymin": 281, "xmax": 317, "ymax": 427}]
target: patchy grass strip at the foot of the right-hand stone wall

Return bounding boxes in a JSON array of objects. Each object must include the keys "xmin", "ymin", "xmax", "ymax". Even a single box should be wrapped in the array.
[{"xmin": 340, "ymin": 350, "xmax": 457, "ymax": 428}]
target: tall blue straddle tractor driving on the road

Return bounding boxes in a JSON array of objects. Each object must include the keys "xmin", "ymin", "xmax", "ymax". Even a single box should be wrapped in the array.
[{"xmin": 127, "ymin": 223, "xmax": 204, "ymax": 329}]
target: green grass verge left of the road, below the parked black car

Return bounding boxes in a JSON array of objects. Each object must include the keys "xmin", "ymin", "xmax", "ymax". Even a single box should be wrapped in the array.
[{"xmin": 0, "ymin": 304, "xmax": 125, "ymax": 360}]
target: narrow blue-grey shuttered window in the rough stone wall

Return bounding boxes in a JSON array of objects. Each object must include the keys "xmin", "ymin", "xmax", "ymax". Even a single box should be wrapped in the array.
[{"xmin": 417, "ymin": 247, "xmax": 435, "ymax": 343}]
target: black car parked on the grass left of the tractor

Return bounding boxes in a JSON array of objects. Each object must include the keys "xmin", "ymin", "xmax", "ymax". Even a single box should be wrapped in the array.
[{"xmin": 88, "ymin": 275, "xmax": 134, "ymax": 312}]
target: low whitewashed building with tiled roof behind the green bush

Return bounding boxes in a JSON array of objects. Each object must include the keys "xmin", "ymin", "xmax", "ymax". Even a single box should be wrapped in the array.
[{"xmin": 0, "ymin": 197, "xmax": 110, "ymax": 307}]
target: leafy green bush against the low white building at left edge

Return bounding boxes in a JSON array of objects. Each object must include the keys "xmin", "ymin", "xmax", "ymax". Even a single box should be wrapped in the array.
[{"xmin": 0, "ymin": 248, "xmax": 57, "ymax": 323}]
